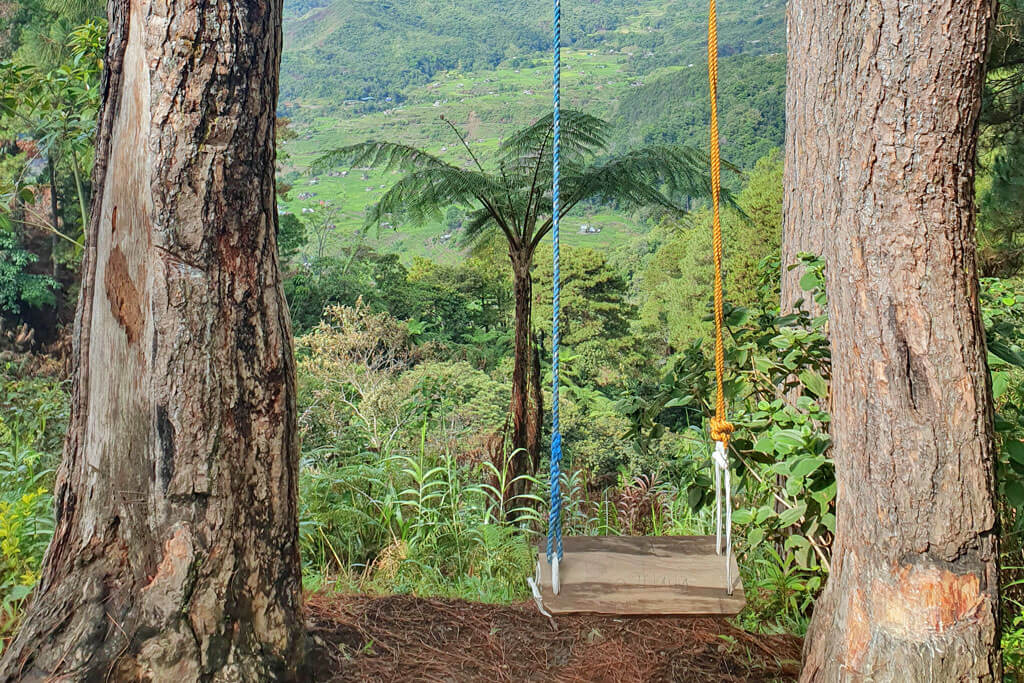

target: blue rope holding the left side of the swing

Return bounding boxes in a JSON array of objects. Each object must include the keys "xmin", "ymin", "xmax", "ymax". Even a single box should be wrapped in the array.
[{"xmin": 548, "ymin": 0, "xmax": 562, "ymax": 563}]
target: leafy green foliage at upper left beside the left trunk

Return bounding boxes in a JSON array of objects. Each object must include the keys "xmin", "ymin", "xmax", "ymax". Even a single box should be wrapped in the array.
[{"xmin": 0, "ymin": 22, "xmax": 105, "ymax": 315}]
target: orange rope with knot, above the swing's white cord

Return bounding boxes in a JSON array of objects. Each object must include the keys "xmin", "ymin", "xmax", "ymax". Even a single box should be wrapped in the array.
[{"xmin": 708, "ymin": 0, "xmax": 733, "ymax": 445}]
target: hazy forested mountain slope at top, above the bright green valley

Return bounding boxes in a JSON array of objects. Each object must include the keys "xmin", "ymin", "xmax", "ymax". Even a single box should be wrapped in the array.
[{"xmin": 282, "ymin": 0, "xmax": 784, "ymax": 104}]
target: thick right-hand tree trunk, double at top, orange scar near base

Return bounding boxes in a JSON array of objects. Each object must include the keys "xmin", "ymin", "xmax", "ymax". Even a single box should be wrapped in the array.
[{"xmin": 785, "ymin": 0, "xmax": 999, "ymax": 681}]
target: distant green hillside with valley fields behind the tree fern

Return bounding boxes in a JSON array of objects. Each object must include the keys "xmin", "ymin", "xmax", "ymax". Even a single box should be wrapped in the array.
[{"xmin": 280, "ymin": 0, "xmax": 784, "ymax": 260}]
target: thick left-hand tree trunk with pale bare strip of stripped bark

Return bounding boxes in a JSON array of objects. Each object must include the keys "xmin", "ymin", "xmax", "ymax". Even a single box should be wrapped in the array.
[{"xmin": 0, "ymin": 0, "xmax": 303, "ymax": 682}]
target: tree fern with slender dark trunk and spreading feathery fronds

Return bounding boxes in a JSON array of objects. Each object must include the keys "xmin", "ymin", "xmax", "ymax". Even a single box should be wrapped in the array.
[{"xmin": 315, "ymin": 111, "xmax": 709, "ymax": 497}]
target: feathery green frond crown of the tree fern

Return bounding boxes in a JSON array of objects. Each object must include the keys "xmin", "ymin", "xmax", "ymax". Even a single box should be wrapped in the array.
[{"xmin": 312, "ymin": 110, "xmax": 731, "ymax": 249}]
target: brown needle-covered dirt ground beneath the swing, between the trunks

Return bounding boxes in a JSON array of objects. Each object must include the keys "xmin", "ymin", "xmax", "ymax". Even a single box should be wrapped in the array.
[{"xmin": 306, "ymin": 594, "xmax": 801, "ymax": 683}]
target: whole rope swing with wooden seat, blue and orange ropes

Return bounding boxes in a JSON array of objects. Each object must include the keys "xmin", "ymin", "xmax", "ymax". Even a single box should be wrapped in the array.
[{"xmin": 527, "ymin": 0, "xmax": 745, "ymax": 615}]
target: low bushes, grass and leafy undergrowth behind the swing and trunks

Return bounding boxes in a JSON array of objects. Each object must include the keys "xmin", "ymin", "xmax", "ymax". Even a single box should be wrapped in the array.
[{"xmin": 0, "ymin": 274, "xmax": 1024, "ymax": 680}]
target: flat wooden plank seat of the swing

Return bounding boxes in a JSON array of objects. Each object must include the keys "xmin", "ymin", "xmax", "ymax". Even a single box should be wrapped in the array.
[{"xmin": 538, "ymin": 536, "xmax": 746, "ymax": 615}]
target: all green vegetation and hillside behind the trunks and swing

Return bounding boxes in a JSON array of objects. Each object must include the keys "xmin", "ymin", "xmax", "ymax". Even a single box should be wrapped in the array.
[{"xmin": 0, "ymin": 0, "xmax": 1024, "ymax": 671}]
